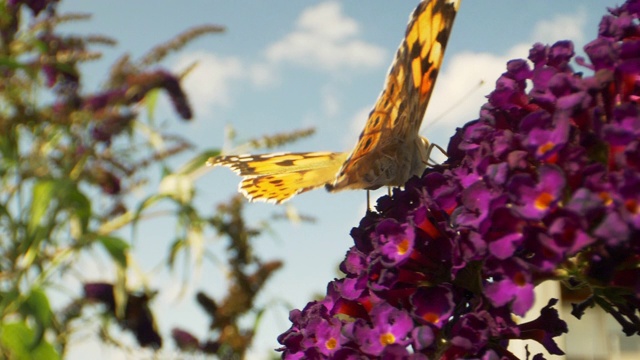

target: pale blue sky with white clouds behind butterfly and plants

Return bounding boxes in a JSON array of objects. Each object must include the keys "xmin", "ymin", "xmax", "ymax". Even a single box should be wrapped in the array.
[{"xmin": 55, "ymin": 0, "xmax": 621, "ymax": 359}]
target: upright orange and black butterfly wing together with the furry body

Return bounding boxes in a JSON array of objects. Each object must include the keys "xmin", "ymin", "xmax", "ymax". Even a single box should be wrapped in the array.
[{"xmin": 327, "ymin": 0, "xmax": 460, "ymax": 191}]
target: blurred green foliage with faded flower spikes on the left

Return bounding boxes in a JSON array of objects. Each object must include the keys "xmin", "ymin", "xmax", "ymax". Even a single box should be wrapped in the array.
[{"xmin": 0, "ymin": 0, "xmax": 292, "ymax": 359}]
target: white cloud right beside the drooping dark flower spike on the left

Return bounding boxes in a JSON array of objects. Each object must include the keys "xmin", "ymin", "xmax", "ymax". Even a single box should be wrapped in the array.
[{"xmin": 173, "ymin": 52, "xmax": 248, "ymax": 115}]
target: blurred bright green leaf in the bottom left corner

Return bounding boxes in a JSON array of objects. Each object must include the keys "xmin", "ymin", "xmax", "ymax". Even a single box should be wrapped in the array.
[{"xmin": 0, "ymin": 322, "xmax": 60, "ymax": 360}]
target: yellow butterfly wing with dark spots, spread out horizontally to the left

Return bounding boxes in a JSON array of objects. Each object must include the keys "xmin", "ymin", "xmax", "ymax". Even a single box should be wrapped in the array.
[{"xmin": 207, "ymin": 152, "xmax": 347, "ymax": 204}]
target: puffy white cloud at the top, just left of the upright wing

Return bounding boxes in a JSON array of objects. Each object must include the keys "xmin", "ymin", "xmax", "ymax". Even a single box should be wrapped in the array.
[{"xmin": 265, "ymin": 1, "xmax": 385, "ymax": 70}]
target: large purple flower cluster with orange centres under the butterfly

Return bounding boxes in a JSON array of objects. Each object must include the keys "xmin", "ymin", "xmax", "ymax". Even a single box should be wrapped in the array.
[{"xmin": 278, "ymin": 0, "xmax": 640, "ymax": 359}]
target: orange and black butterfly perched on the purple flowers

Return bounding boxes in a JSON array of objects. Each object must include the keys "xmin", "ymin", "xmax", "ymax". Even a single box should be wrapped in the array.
[{"xmin": 207, "ymin": 0, "xmax": 461, "ymax": 204}]
